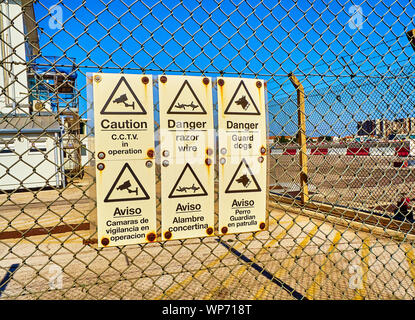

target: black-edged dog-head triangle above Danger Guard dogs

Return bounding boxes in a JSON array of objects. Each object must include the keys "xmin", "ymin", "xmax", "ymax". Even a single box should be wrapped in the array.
[{"xmin": 224, "ymin": 80, "xmax": 261, "ymax": 115}]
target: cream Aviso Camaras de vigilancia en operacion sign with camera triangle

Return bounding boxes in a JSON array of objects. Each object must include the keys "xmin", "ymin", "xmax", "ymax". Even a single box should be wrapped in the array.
[{"xmin": 96, "ymin": 160, "xmax": 157, "ymax": 247}]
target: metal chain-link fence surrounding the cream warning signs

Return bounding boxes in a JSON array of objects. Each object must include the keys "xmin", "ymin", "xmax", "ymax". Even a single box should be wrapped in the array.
[{"xmin": 0, "ymin": 0, "xmax": 415, "ymax": 300}]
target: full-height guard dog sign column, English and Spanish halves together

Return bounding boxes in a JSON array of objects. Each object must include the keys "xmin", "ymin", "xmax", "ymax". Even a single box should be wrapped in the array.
[{"xmin": 217, "ymin": 78, "xmax": 268, "ymax": 234}]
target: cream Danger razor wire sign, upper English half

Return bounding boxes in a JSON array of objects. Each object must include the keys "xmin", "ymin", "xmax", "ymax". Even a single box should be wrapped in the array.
[{"xmin": 159, "ymin": 76, "xmax": 214, "ymax": 163}]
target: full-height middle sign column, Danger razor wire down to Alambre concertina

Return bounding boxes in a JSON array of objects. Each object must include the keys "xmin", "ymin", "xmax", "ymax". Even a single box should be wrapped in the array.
[{"xmin": 158, "ymin": 75, "xmax": 215, "ymax": 240}]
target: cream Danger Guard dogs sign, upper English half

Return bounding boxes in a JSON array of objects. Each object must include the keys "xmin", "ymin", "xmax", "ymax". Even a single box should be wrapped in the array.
[{"xmin": 217, "ymin": 78, "xmax": 267, "ymax": 156}]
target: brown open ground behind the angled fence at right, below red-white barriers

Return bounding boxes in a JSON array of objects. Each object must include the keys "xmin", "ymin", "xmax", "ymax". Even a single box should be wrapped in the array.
[{"xmin": 270, "ymin": 155, "xmax": 415, "ymax": 215}]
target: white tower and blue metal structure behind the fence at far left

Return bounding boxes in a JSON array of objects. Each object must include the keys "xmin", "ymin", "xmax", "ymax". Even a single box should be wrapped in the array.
[{"xmin": 0, "ymin": 0, "xmax": 83, "ymax": 189}]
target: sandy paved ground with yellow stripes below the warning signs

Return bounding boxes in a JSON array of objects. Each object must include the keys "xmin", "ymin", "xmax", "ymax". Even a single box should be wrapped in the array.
[{"xmin": 0, "ymin": 160, "xmax": 415, "ymax": 299}]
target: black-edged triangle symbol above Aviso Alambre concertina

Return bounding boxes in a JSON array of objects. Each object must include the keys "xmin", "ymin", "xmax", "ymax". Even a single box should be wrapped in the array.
[{"xmin": 169, "ymin": 163, "xmax": 207, "ymax": 198}]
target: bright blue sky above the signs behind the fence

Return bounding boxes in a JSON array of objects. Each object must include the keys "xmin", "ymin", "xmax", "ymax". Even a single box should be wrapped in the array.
[{"xmin": 30, "ymin": 0, "xmax": 415, "ymax": 135}]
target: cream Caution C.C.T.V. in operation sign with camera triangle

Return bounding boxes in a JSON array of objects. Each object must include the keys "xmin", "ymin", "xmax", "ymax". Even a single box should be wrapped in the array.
[{"xmin": 93, "ymin": 73, "xmax": 154, "ymax": 160}]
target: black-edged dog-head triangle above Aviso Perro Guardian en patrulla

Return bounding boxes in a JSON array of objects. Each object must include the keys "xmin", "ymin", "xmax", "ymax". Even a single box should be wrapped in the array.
[{"xmin": 225, "ymin": 159, "xmax": 261, "ymax": 193}]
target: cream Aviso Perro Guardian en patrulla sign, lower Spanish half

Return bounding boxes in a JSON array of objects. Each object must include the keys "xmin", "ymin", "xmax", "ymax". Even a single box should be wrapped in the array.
[{"xmin": 219, "ymin": 157, "xmax": 268, "ymax": 234}]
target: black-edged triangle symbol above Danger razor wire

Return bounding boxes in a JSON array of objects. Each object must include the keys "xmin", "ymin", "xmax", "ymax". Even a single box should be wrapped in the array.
[{"xmin": 167, "ymin": 80, "xmax": 206, "ymax": 114}]
